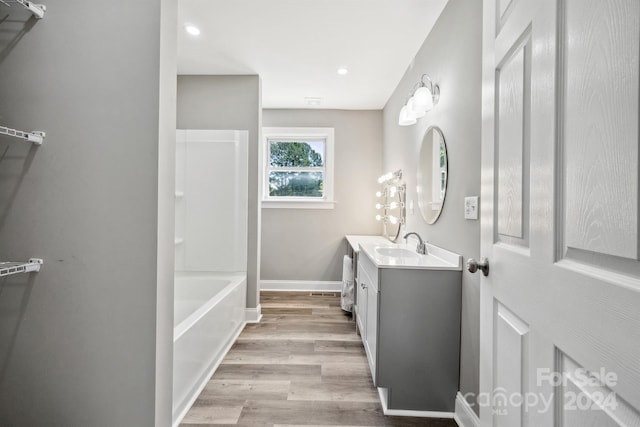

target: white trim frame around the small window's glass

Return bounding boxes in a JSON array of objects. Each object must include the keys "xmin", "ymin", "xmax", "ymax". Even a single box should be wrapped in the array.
[{"xmin": 260, "ymin": 127, "xmax": 336, "ymax": 209}]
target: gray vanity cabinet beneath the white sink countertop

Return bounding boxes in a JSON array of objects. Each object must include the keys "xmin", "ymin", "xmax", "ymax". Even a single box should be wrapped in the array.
[{"xmin": 358, "ymin": 252, "xmax": 462, "ymax": 413}]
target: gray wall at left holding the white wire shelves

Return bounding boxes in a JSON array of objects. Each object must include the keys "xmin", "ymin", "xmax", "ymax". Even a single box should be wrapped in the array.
[{"xmin": 0, "ymin": 0, "xmax": 176, "ymax": 426}]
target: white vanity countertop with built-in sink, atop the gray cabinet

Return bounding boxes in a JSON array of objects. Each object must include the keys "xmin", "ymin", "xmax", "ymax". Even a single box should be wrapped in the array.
[{"xmin": 360, "ymin": 239, "xmax": 462, "ymax": 271}]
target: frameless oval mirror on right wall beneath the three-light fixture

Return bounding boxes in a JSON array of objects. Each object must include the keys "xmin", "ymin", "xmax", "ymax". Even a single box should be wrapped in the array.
[{"xmin": 417, "ymin": 126, "xmax": 447, "ymax": 224}]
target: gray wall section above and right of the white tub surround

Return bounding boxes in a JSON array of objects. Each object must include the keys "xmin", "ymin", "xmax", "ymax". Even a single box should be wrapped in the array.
[{"xmin": 177, "ymin": 75, "xmax": 262, "ymax": 308}]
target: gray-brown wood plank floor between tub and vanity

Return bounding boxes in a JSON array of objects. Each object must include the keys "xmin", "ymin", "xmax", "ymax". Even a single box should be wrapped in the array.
[{"xmin": 181, "ymin": 292, "xmax": 456, "ymax": 427}]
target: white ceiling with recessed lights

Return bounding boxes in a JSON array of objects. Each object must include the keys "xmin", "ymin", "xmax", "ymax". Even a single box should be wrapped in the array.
[{"xmin": 178, "ymin": 0, "xmax": 447, "ymax": 109}]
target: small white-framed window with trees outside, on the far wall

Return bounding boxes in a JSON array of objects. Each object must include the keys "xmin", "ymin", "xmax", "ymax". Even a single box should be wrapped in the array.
[{"xmin": 262, "ymin": 128, "xmax": 334, "ymax": 209}]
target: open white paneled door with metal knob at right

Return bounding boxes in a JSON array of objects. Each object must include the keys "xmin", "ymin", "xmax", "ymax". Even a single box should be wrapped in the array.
[{"xmin": 477, "ymin": 0, "xmax": 640, "ymax": 427}]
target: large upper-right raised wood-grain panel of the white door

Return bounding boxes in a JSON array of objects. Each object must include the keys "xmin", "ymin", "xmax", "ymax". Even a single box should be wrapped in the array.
[{"xmin": 559, "ymin": 0, "xmax": 640, "ymax": 260}]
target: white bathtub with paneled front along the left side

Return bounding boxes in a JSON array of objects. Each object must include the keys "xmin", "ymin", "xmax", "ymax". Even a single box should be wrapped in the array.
[{"xmin": 173, "ymin": 273, "xmax": 247, "ymax": 426}]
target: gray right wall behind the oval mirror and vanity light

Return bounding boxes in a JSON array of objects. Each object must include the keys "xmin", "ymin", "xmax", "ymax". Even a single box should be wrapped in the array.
[{"xmin": 384, "ymin": 0, "xmax": 482, "ymax": 410}]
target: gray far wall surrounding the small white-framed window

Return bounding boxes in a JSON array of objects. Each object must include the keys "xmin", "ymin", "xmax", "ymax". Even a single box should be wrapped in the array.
[{"xmin": 260, "ymin": 109, "xmax": 382, "ymax": 281}]
